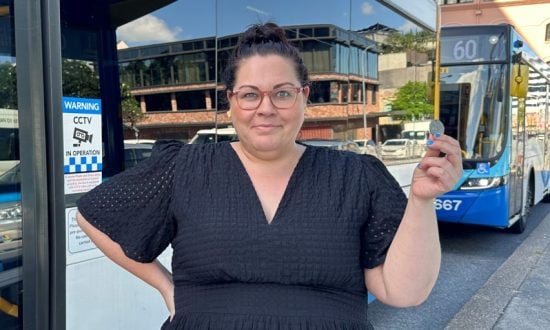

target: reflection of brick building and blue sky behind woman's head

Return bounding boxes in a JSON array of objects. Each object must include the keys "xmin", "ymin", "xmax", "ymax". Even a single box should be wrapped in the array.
[{"xmin": 118, "ymin": 0, "xmax": 434, "ymax": 166}]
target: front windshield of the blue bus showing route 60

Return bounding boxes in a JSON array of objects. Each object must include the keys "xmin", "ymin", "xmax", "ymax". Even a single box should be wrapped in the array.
[{"xmin": 440, "ymin": 64, "xmax": 508, "ymax": 161}]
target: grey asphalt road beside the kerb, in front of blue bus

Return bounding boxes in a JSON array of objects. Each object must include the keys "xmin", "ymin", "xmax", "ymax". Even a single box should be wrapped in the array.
[{"xmin": 368, "ymin": 197, "xmax": 550, "ymax": 329}]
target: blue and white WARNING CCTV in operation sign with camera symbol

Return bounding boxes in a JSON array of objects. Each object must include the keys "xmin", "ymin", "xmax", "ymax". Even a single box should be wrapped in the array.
[{"xmin": 62, "ymin": 97, "xmax": 103, "ymax": 194}]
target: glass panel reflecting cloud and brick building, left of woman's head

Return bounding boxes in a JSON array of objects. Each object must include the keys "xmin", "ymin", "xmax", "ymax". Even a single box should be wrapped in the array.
[{"xmin": 117, "ymin": 0, "xmax": 218, "ymax": 142}]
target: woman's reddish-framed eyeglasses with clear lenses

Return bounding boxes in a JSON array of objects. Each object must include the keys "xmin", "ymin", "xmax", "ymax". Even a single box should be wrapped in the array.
[{"xmin": 229, "ymin": 87, "xmax": 304, "ymax": 110}]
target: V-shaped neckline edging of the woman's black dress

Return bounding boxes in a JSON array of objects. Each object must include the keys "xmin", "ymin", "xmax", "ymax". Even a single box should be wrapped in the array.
[{"xmin": 228, "ymin": 143, "xmax": 310, "ymax": 226}]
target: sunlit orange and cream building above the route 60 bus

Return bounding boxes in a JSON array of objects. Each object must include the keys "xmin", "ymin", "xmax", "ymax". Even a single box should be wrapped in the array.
[{"xmin": 440, "ymin": 0, "xmax": 550, "ymax": 63}]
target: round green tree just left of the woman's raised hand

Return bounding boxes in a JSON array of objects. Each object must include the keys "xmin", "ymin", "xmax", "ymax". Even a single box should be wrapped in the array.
[{"xmin": 391, "ymin": 81, "xmax": 434, "ymax": 119}]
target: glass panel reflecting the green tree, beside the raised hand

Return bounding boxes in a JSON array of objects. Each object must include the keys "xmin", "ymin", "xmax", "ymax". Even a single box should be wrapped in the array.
[{"xmin": 349, "ymin": 0, "xmax": 435, "ymax": 163}]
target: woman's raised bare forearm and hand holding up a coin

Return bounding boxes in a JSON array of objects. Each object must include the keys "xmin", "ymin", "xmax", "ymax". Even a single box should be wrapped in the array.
[{"xmin": 365, "ymin": 135, "xmax": 462, "ymax": 307}]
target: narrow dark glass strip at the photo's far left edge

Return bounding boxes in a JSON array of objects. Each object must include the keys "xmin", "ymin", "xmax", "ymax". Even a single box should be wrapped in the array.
[{"xmin": 0, "ymin": 1, "xmax": 23, "ymax": 329}]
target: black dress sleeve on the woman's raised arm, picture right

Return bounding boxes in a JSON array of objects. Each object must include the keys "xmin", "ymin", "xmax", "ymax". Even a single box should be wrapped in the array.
[{"xmin": 361, "ymin": 155, "xmax": 407, "ymax": 268}]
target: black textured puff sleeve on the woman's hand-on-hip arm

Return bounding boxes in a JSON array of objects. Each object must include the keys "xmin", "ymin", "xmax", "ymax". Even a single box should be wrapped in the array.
[{"xmin": 76, "ymin": 141, "xmax": 183, "ymax": 262}]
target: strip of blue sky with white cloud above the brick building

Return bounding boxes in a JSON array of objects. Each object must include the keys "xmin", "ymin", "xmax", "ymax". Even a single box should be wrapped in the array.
[{"xmin": 117, "ymin": 0, "xmax": 426, "ymax": 47}]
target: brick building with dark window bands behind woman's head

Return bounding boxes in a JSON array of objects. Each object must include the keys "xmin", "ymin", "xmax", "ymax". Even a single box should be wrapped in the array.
[{"xmin": 118, "ymin": 24, "xmax": 380, "ymax": 139}]
